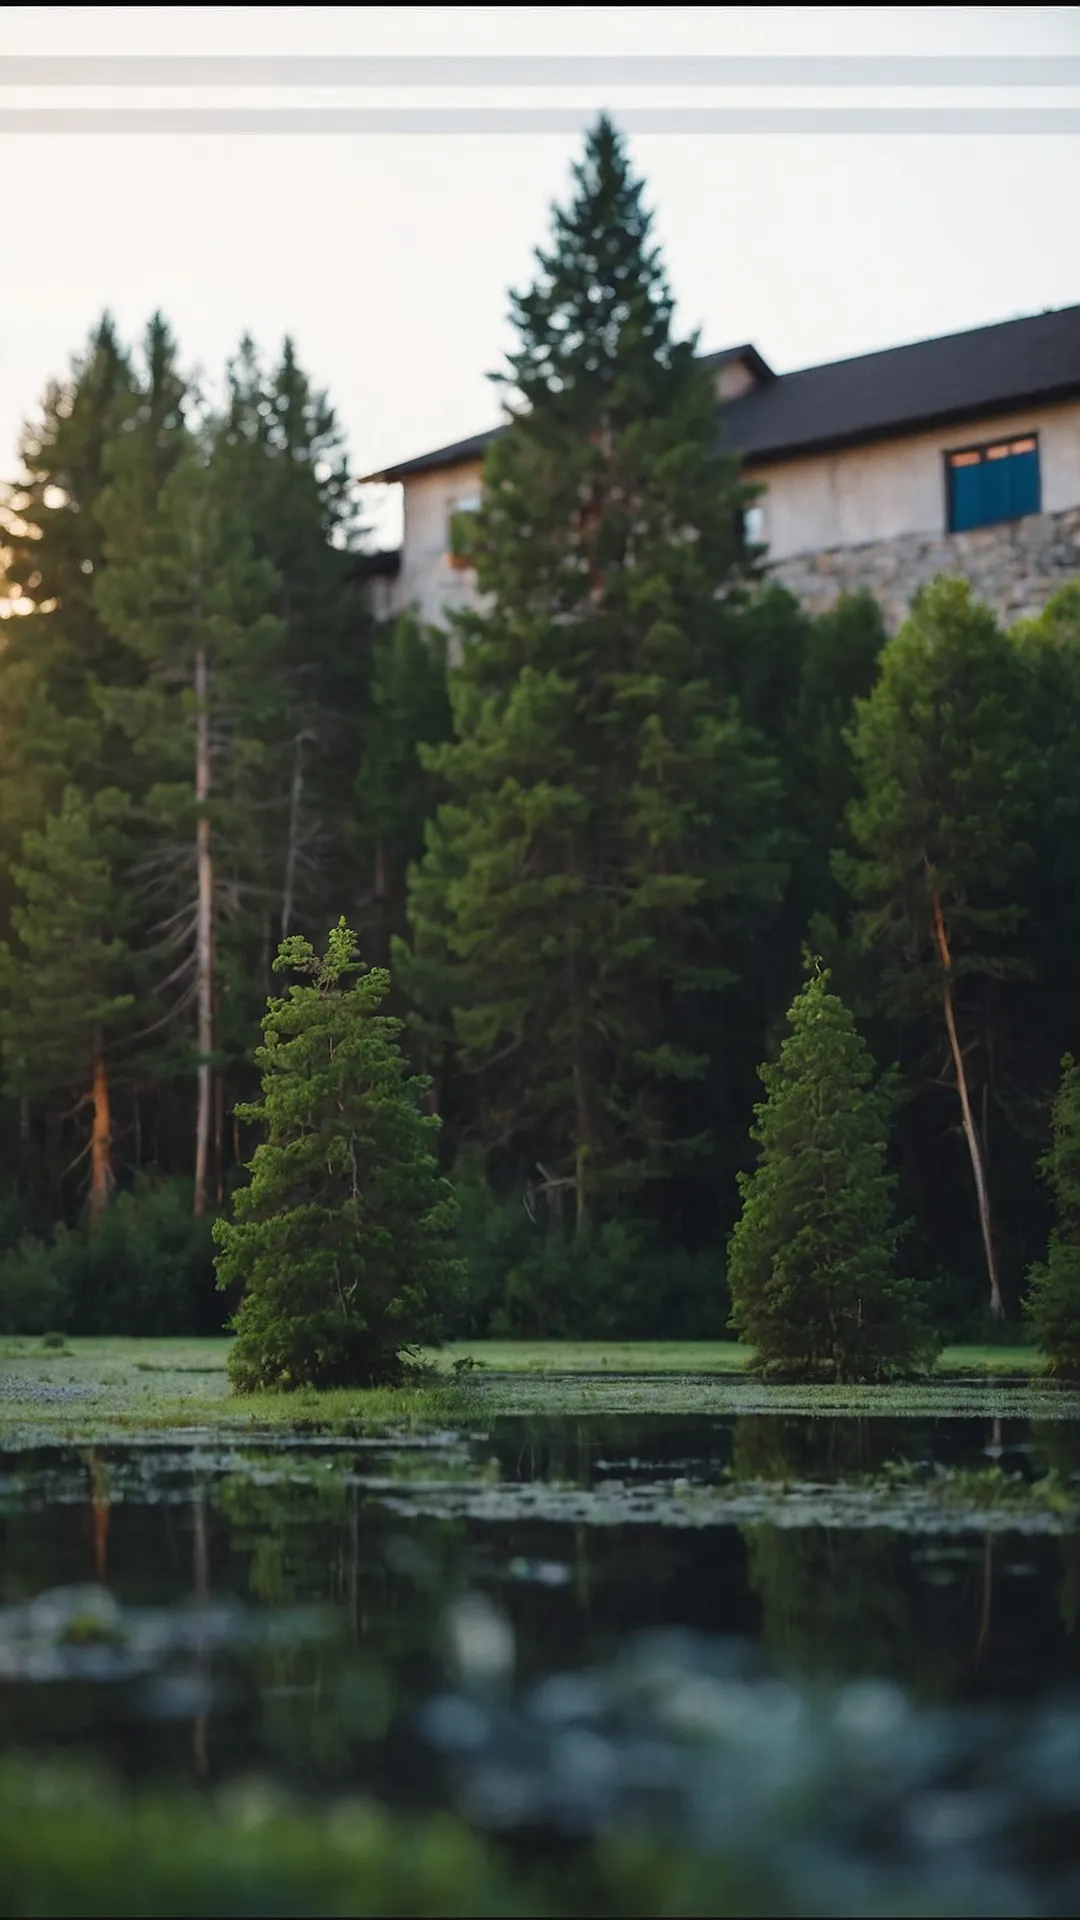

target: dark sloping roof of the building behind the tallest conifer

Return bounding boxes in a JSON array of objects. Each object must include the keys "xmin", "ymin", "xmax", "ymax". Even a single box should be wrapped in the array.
[{"xmin": 365, "ymin": 307, "xmax": 1080, "ymax": 482}]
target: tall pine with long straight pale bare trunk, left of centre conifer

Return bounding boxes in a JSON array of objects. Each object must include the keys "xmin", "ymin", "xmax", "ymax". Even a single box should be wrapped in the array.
[{"xmin": 98, "ymin": 360, "xmax": 281, "ymax": 1213}]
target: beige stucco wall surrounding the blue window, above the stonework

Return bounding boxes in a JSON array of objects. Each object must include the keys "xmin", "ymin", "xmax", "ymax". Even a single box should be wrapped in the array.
[{"xmin": 748, "ymin": 401, "xmax": 1080, "ymax": 561}]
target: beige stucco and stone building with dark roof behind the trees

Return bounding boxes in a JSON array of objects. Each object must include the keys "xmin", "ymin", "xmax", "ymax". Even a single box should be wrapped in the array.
[{"xmin": 367, "ymin": 307, "xmax": 1080, "ymax": 628}]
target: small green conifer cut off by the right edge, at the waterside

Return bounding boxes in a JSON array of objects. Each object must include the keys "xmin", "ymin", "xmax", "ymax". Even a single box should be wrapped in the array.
[{"xmin": 1026, "ymin": 1054, "xmax": 1080, "ymax": 1379}]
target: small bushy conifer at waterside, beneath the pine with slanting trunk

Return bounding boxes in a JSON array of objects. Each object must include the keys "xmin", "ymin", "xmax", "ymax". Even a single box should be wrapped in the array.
[{"xmin": 728, "ymin": 972, "xmax": 930, "ymax": 1382}]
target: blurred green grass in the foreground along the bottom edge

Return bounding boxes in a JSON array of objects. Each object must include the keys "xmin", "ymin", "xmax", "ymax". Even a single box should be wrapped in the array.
[{"xmin": 0, "ymin": 1763, "xmax": 784, "ymax": 1916}]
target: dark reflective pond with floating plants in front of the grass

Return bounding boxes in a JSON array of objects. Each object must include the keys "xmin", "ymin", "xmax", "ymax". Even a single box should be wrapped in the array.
[{"xmin": 0, "ymin": 1394, "xmax": 1080, "ymax": 1912}]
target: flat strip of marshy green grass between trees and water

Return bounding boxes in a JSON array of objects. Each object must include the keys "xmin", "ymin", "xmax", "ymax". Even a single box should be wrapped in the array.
[{"xmin": 0, "ymin": 1336, "xmax": 1060, "ymax": 1438}]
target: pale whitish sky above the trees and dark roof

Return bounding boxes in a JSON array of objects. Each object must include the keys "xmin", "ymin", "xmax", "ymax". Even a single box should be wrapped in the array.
[{"xmin": 0, "ymin": 6, "xmax": 1080, "ymax": 541}]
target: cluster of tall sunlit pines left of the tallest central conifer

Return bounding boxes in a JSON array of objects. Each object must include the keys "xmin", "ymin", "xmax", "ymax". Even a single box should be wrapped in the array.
[{"xmin": 0, "ymin": 317, "xmax": 448, "ymax": 1331}]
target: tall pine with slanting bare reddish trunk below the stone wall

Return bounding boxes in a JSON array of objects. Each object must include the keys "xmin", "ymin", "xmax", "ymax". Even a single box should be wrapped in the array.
[{"xmin": 838, "ymin": 580, "xmax": 1038, "ymax": 1319}]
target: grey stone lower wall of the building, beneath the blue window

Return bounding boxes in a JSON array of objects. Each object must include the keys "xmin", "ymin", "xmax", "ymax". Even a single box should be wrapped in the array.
[{"xmin": 769, "ymin": 507, "xmax": 1080, "ymax": 632}]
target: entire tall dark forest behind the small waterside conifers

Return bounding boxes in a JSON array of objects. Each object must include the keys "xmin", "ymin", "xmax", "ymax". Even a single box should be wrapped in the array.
[{"xmin": 0, "ymin": 123, "xmax": 1080, "ymax": 1336}]
